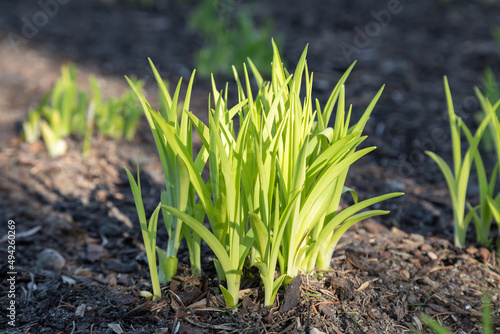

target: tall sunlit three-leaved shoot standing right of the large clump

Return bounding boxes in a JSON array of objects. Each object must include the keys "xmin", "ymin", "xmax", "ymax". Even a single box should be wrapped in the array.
[{"xmin": 426, "ymin": 77, "xmax": 491, "ymax": 247}]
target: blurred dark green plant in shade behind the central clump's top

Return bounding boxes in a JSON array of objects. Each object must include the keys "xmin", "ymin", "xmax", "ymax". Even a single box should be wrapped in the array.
[{"xmin": 189, "ymin": 0, "xmax": 280, "ymax": 77}]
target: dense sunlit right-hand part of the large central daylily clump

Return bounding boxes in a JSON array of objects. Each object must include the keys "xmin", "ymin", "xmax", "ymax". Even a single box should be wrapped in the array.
[{"xmin": 237, "ymin": 45, "xmax": 401, "ymax": 305}]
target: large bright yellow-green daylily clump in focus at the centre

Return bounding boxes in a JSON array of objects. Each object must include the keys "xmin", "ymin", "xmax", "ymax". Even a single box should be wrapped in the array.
[{"xmin": 129, "ymin": 42, "xmax": 401, "ymax": 307}]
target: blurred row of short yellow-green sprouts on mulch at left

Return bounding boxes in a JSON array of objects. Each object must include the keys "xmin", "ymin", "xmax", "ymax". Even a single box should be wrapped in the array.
[{"xmin": 22, "ymin": 64, "xmax": 143, "ymax": 156}]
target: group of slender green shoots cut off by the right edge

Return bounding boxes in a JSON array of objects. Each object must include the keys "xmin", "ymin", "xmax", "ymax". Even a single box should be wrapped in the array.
[{"xmin": 426, "ymin": 77, "xmax": 500, "ymax": 247}]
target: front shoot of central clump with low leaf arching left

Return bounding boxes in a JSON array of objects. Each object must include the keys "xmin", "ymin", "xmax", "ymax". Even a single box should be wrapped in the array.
[{"xmin": 159, "ymin": 83, "xmax": 254, "ymax": 307}]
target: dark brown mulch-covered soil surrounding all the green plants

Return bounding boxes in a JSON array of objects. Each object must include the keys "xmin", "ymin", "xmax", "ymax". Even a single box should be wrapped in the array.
[{"xmin": 0, "ymin": 0, "xmax": 500, "ymax": 334}]
